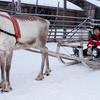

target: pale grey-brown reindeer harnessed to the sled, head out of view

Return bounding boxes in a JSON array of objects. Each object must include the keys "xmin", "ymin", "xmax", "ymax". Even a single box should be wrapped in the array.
[{"xmin": 0, "ymin": 12, "xmax": 51, "ymax": 92}]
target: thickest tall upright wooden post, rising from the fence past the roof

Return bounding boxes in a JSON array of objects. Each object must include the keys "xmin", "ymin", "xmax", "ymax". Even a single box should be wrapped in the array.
[{"xmin": 63, "ymin": 0, "xmax": 67, "ymax": 39}]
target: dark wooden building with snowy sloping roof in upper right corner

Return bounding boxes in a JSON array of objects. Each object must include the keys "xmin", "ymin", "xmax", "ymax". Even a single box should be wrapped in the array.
[{"xmin": 68, "ymin": 0, "xmax": 100, "ymax": 19}]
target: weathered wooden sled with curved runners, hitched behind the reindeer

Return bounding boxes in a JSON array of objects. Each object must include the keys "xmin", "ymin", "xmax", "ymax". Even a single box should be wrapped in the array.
[{"xmin": 56, "ymin": 41, "xmax": 100, "ymax": 70}]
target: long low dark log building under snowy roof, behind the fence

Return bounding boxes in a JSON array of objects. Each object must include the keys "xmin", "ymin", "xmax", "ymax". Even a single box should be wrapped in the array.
[{"xmin": 0, "ymin": 0, "xmax": 83, "ymax": 16}]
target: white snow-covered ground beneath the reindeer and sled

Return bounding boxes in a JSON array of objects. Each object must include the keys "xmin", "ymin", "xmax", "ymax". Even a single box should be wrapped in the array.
[{"xmin": 0, "ymin": 43, "xmax": 100, "ymax": 100}]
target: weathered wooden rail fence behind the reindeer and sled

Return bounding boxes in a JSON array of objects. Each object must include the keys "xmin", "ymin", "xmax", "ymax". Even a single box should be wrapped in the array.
[{"xmin": 0, "ymin": 9, "xmax": 100, "ymax": 42}]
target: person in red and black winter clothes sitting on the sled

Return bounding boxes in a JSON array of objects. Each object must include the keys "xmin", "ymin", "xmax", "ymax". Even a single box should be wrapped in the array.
[{"xmin": 74, "ymin": 26, "xmax": 100, "ymax": 58}]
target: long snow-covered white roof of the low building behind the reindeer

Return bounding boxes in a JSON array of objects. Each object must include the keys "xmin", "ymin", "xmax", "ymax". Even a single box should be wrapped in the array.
[{"xmin": 0, "ymin": 0, "xmax": 83, "ymax": 11}]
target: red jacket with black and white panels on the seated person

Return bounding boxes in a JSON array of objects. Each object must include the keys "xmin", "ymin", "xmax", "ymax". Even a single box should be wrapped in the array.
[{"xmin": 87, "ymin": 34, "xmax": 100, "ymax": 48}]
